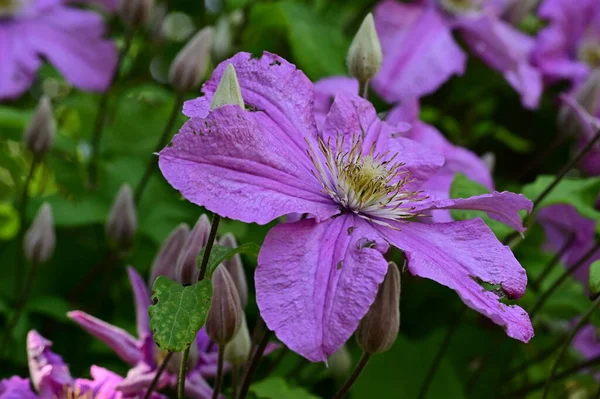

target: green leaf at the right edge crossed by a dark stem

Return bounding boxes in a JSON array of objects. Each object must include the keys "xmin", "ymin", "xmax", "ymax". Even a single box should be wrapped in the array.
[{"xmin": 523, "ymin": 176, "xmax": 600, "ymax": 227}]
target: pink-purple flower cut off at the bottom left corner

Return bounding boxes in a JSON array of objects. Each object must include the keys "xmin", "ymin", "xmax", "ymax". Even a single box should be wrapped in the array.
[{"xmin": 0, "ymin": 330, "xmax": 148, "ymax": 399}]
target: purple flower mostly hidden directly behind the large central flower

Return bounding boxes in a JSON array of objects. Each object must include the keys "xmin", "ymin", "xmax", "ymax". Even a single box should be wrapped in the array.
[{"xmin": 315, "ymin": 76, "xmax": 494, "ymax": 222}]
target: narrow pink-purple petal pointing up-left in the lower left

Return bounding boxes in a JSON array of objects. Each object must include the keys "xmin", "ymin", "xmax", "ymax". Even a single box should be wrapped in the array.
[{"xmin": 67, "ymin": 310, "xmax": 144, "ymax": 365}]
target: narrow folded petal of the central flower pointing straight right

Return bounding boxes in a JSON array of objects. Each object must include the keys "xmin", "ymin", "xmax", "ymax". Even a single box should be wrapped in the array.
[{"xmin": 416, "ymin": 191, "xmax": 533, "ymax": 233}]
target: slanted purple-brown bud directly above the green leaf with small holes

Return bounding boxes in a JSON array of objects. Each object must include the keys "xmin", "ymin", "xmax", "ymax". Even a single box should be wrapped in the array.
[{"xmin": 175, "ymin": 215, "xmax": 210, "ymax": 284}]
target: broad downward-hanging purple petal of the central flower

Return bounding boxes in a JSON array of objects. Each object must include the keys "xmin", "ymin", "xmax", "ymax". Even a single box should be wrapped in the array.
[{"xmin": 255, "ymin": 215, "xmax": 387, "ymax": 362}]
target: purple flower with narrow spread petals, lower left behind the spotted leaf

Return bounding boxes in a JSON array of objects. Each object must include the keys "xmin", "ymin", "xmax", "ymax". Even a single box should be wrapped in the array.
[{"xmin": 69, "ymin": 267, "xmax": 218, "ymax": 399}]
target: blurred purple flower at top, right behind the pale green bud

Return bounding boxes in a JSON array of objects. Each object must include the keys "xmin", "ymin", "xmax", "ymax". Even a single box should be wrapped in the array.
[{"xmin": 373, "ymin": 0, "xmax": 542, "ymax": 108}]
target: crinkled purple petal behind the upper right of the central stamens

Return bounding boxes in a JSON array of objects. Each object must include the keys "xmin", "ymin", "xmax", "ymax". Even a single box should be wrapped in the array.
[{"xmin": 322, "ymin": 93, "xmax": 444, "ymax": 192}]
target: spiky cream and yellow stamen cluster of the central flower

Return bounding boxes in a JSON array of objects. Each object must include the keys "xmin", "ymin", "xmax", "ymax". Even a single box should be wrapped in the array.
[{"xmin": 308, "ymin": 136, "xmax": 426, "ymax": 224}]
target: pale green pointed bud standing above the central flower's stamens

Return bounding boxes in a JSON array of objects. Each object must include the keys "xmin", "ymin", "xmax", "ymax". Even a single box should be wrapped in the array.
[{"xmin": 347, "ymin": 13, "xmax": 383, "ymax": 84}]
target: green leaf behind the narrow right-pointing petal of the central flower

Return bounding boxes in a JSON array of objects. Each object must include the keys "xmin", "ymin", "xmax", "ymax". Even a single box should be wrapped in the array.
[{"xmin": 450, "ymin": 173, "xmax": 513, "ymax": 239}]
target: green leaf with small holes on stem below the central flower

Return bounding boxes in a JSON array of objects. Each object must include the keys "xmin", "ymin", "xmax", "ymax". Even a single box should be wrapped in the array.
[{"xmin": 149, "ymin": 276, "xmax": 212, "ymax": 352}]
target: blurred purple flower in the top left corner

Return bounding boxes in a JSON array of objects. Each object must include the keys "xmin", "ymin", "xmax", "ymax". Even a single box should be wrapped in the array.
[{"xmin": 0, "ymin": 0, "xmax": 117, "ymax": 100}]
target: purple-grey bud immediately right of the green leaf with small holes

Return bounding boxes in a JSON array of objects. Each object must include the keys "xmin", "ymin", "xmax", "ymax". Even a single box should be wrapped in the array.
[{"xmin": 206, "ymin": 265, "xmax": 244, "ymax": 345}]
